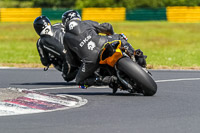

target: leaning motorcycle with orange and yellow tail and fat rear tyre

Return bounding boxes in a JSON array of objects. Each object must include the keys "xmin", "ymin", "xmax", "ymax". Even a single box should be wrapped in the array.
[{"xmin": 96, "ymin": 40, "xmax": 157, "ymax": 96}]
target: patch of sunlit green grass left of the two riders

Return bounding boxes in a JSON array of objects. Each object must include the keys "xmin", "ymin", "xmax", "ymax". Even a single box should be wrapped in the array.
[{"xmin": 0, "ymin": 23, "xmax": 39, "ymax": 63}]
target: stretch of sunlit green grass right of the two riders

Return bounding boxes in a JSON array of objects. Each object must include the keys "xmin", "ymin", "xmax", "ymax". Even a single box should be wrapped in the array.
[{"xmin": 113, "ymin": 21, "xmax": 200, "ymax": 67}]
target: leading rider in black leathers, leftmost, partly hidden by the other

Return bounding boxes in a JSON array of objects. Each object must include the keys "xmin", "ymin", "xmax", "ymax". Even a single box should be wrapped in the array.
[{"xmin": 33, "ymin": 16, "xmax": 77, "ymax": 81}]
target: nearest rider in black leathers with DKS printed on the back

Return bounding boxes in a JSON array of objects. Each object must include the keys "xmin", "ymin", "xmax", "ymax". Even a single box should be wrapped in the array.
[{"xmin": 62, "ymin": 10, "xmax": 146, "ymax": 86}]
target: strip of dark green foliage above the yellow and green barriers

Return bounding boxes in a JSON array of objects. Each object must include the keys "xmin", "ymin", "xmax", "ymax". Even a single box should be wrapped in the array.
[{"xmin": 0, "ymin": 0, "xmax": 200, "ymax": 9}]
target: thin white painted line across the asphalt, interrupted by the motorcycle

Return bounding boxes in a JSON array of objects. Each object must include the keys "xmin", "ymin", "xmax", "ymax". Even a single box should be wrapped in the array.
[{"xmin": 31, "ymin": 78, "xmax": 200, "ymax": 90}]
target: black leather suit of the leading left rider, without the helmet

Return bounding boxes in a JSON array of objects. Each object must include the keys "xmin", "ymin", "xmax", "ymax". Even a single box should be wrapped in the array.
[{"xmin": 37, "ymin": 23, "xmax": 77, "ymax": 81}]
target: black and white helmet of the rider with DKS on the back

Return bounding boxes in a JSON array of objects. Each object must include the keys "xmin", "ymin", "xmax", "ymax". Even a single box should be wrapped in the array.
[{"xmin": 62, "ymin": 10, "xmax": 81, "ymax": 26}]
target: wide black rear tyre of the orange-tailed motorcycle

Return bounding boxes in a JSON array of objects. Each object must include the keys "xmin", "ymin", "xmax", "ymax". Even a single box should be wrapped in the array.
[{"xmin": 117, "ymin": 58, "xmax": 157, "ymax": 96}]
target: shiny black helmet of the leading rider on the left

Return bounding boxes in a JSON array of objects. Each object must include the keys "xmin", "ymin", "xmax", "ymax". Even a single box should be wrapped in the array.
[{"xmin": 33, "ymin": 16, "xmax": 51, "ymax": 35}]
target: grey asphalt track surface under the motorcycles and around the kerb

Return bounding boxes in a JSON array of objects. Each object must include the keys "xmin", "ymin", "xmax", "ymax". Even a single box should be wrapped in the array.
[{"xmin": 0, "ymin": 69, "xmax": 200, "ymax": 133}]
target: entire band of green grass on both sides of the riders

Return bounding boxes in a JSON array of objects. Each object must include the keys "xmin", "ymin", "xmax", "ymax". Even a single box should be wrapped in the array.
[{"xmin": 0, "ymin": 21, "xmax": 200, "ymax": 68}]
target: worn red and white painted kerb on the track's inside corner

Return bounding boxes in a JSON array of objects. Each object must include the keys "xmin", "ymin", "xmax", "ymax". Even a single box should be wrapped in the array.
[{"xmin": 0, "ymin": 88, "xmax": 87, "ymax": 116}]
